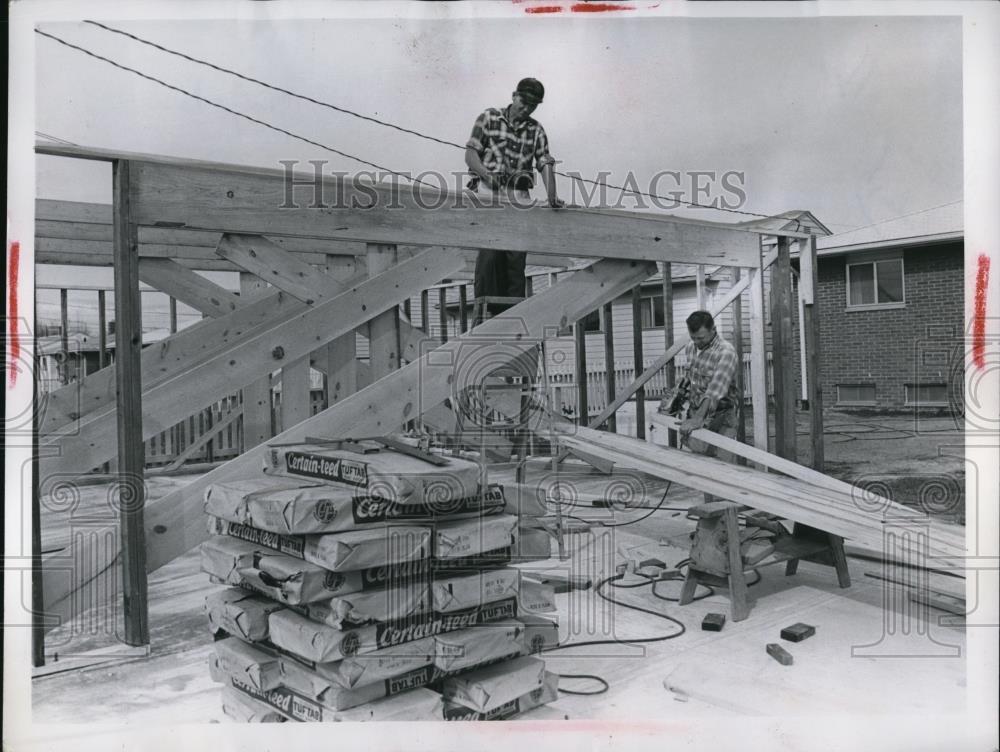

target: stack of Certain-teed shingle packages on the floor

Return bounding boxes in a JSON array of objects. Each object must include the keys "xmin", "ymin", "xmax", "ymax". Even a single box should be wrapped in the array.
[{"xmin": 201, "ymin": 443, "xmax": 558, "ymax": 722}]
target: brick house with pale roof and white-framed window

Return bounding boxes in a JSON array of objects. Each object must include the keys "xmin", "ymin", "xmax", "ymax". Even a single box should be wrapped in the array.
[{"xmin": 817, "ymin": 202, "xmax": 964, "ymax": 410}]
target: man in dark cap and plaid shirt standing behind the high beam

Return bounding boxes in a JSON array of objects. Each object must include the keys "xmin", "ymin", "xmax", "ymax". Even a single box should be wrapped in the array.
[{"xmin": 465, "ymin": 78, "xmax": 565, "ymax": 323}]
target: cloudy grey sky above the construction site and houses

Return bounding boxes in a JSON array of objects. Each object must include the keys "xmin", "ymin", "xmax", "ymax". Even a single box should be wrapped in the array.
[{"xmin": 35, "ymin": 11, "xmax": 963, "ymax": 322}]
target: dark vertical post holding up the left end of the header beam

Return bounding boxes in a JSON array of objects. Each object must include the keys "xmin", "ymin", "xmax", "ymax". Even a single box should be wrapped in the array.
[{"xmin": 112, "ymin": 160, "xmax": 149, "ymax": 646}]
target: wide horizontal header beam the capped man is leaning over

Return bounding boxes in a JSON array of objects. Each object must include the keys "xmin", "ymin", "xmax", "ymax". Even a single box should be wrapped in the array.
[{"xmin": 123, "ymin": 161, "xmax": 757, "ymax": 266}]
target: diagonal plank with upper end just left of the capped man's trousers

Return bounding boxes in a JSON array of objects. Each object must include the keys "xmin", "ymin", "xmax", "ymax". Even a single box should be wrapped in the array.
[{"xmin": 42, "ymin": 248, "xmax": 464, "ymax": 472}]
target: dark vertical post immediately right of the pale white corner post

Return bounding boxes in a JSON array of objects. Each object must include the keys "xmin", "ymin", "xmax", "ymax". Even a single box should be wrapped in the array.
[{"xmin": 771, "ymin": 235, "xmax": 795, "ymax": 461}]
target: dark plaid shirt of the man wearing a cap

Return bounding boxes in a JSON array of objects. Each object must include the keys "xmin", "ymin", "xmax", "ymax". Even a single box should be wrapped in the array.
[{"xmin": 465, "ymin": 107, "xmax": 555, "ymax": 190}]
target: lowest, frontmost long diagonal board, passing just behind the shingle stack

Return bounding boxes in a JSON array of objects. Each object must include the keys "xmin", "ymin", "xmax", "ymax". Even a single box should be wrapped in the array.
[{"xmin": 33, "ymin": 260, "xmax": 655, "ymax": 624}]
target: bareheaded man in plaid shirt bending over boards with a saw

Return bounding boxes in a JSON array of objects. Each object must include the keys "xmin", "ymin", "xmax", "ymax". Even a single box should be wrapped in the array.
[{"xmin": 660, "ymin": 311, "xmax": 740, "ymax": 501}]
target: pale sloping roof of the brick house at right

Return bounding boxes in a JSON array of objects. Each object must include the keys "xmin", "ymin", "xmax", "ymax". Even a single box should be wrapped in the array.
[{"xmin": 816, "ymin": 201, "xmax": 965, "ymax": 256}]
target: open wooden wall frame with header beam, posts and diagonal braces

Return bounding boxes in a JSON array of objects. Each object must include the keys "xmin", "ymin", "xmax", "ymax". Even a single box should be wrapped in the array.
[{"xmin": 35, "ymin": 144, "xmax": 822, "ymax": 645}]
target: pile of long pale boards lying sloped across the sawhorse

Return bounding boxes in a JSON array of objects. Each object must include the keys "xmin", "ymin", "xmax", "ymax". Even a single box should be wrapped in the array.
[{"xmin": 557, "ymin": 428, "xmax": 965, "ymax": 563}]
